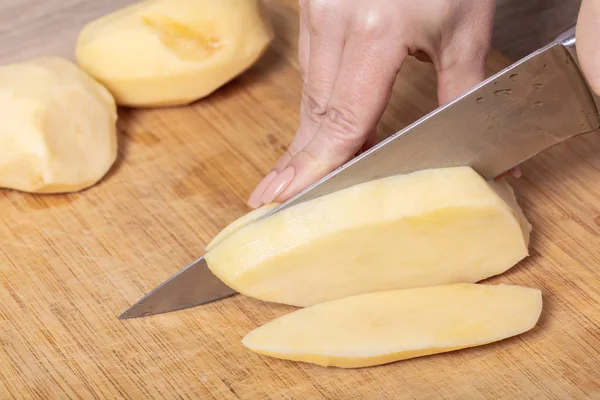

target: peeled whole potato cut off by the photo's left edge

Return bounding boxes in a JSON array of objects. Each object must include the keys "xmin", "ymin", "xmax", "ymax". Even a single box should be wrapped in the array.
[{"xmin": 0, "ymin": 57, "xmax": 117, "ymax": 193}]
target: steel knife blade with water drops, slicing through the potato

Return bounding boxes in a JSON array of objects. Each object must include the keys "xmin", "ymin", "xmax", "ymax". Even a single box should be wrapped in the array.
[{"xmin": 120, "ymin": 26, "xmax": 600, "ymax": 319}]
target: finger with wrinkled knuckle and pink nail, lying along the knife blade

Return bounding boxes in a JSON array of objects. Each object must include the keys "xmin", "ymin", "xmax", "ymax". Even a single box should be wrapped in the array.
[{"xmin": 262, "ymin": 35, "xmax": 407, "ymax": 203}]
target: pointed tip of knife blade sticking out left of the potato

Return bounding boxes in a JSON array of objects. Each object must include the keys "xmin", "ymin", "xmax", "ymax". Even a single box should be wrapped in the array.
[{"xmin": 119, "ymin": 257, "xmax": 236, "ymax": 319}]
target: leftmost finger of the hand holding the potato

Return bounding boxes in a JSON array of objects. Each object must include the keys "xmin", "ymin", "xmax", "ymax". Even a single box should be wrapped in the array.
[{"xmin": 248, "ymin": 1, "xmax": 345, "ymax": 208}]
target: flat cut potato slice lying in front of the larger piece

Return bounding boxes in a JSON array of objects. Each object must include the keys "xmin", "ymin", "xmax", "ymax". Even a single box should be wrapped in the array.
[{"xmin": 242, "ymin": 283, "xmax": 542, "ymax": 368}]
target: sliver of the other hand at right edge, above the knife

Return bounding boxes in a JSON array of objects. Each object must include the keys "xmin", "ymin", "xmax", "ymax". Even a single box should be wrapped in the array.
[{"xmin": 577, "ymin": 0, "xmax": 600, "ymax": 96}]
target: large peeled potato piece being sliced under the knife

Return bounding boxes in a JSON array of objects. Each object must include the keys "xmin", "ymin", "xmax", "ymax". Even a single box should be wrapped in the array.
[{"xmin": 205, "ymin": 167, "xmax": 531, "ymax": 306}]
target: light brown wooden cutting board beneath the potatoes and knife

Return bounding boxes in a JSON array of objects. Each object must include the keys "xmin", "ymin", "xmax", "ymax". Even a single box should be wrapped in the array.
[{"xmin": 0, "ymin": 0, "xmax": 600, "ymax": 400}]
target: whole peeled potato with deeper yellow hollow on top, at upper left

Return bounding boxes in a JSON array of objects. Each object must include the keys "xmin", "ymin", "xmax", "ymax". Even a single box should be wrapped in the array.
[{"xmin": 75, "ymin": 0, "xmax": 274, "ymax": 107}]
